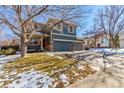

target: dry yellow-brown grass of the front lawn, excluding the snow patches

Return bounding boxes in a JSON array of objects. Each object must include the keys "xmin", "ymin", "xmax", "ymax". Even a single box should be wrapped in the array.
[{"xmin": 0, "ymin": 53, "xmax": 95, "ymax": 87}]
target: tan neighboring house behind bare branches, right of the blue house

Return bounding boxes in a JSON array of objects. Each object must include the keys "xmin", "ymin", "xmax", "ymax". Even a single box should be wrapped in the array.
[{"xmin": 77, "ymin": 32, "xmax": 110, "ymax": 48}]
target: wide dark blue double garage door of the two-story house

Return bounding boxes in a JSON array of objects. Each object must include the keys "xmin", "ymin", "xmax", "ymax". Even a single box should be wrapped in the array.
[{"xmin": 54, "ymin": 41, "xmax": 73, "ymax": 51}]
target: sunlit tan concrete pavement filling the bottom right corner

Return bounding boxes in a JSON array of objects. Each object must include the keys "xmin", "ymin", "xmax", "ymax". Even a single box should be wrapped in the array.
[{"xmin": 68, "ymin": 65, "xmax": 124, "ymax": 88}]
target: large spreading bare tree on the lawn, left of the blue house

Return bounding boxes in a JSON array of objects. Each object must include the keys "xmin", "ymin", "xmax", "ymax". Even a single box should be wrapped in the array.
[{"xmin": 0, "ymin": 5, "xmax": 86, "ymax": 57}]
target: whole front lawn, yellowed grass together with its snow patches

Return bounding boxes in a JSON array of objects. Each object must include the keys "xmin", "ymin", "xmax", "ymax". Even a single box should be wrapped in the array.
[{"xmin": 0, "ymin": 53, "xmax": 96, "ymax": 87}]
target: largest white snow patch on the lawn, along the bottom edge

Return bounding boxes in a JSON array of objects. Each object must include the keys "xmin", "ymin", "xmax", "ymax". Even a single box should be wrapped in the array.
[{"xmin": 6, "ymin": 71, "xmax": 53, "ymax": 88}]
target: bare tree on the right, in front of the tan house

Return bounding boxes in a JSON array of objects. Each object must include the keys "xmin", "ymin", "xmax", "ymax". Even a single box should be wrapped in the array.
[{"xmin": 98, "ymin": 5, "xmax": 124, "ymax": 48}]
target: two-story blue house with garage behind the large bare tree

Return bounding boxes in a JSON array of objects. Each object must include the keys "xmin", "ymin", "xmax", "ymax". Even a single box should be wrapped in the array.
[{"xmin": 28, "ymin": 19, "xmax": 82, "ymax": 51}]
